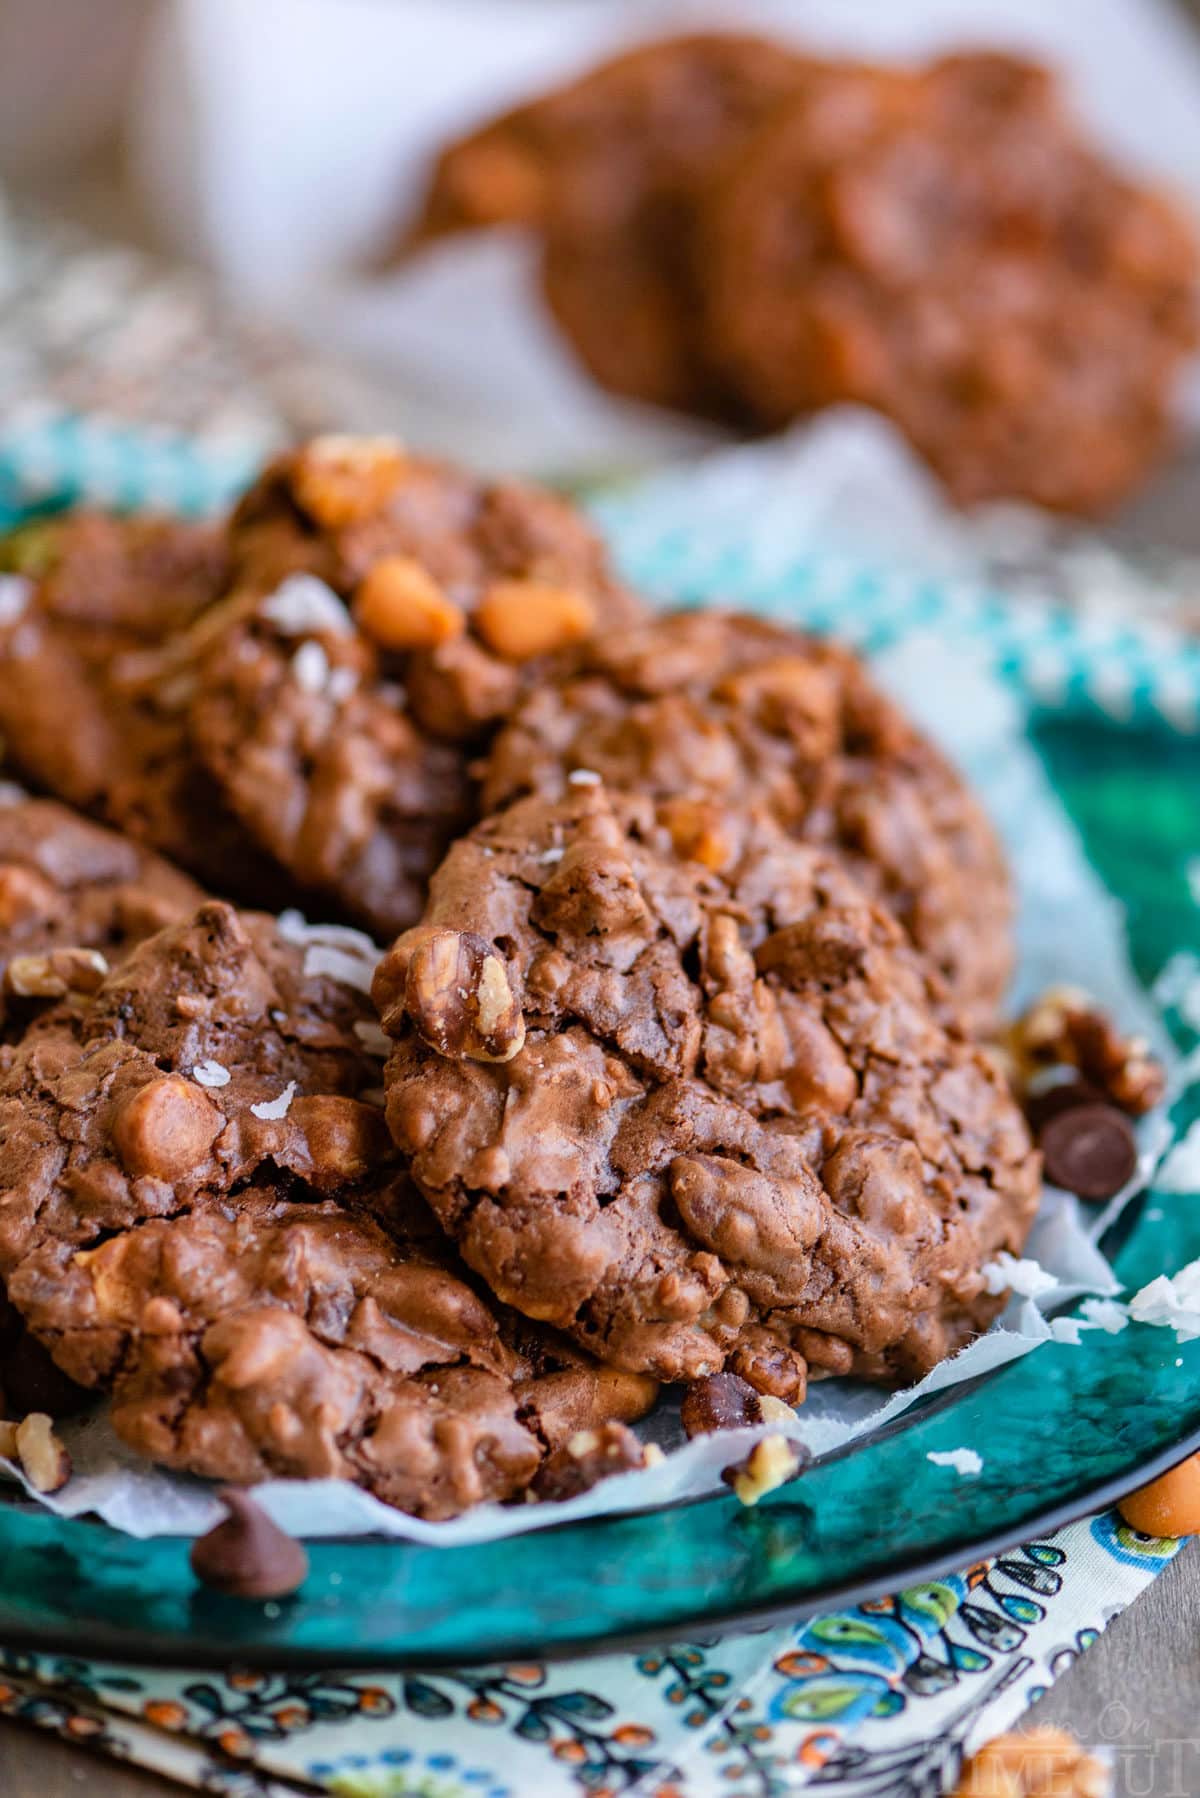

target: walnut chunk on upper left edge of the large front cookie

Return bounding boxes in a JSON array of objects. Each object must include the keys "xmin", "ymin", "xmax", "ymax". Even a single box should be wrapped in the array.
[{"xmin": 399, "ymin": 930, "xmax": 525, "ymax": 1061}]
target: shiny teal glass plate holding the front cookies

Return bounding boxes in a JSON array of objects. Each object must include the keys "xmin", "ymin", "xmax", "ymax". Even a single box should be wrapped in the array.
[{"xmin": 0, "ymin": 719, "xmax": 1200, "ymax": 1669}]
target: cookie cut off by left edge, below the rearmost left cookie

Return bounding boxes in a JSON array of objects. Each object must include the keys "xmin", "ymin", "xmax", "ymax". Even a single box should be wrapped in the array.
[{"xmin": 0, "ymin": 789, "xmax": 203, "ymax": 1043}]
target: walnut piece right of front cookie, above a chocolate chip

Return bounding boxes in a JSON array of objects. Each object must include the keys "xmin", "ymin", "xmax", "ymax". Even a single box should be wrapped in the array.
[{"xmin": 1002, "ymin": 987, "xmax": 1166, "ymax": 1117}]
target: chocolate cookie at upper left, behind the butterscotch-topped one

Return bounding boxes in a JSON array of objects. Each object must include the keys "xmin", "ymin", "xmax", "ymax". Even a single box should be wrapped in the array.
[{"xmin": 0, "ymin": 512, "xmax": 291, "ymax": 904}]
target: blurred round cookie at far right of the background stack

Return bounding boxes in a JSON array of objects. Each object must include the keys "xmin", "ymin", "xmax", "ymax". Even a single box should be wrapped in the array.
[{"xmin": 703, "ymin": 54, "xmax": 1200, "ymax": 512}]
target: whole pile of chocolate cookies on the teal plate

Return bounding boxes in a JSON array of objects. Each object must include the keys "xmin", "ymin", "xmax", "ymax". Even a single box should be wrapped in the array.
[{"xmin": 0, "ymin": 439, "xmax": 1038, "ymax": 1518}]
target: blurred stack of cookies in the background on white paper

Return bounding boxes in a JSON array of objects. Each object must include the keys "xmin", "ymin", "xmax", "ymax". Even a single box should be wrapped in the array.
[{"xmin": 403, "ymin": 32, "xmax": 1200, "ymax": 512}]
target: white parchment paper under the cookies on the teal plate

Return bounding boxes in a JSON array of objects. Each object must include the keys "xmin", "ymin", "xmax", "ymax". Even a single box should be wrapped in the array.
[{"xmin": 0, "ymin": 636, "xmax": 1191, "ymax": 1546}]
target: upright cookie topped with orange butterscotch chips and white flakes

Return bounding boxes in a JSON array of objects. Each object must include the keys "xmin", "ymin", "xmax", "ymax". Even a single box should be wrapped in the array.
[{"xmin": 191, "ymin": 439, "xmax": 639, "ymax": 935}]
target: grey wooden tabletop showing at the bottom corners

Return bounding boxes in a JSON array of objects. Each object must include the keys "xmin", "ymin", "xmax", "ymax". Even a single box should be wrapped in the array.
[{"xmin": 0, "ymin": 1543, "xmax": 1200, "ymax": 1798}]
